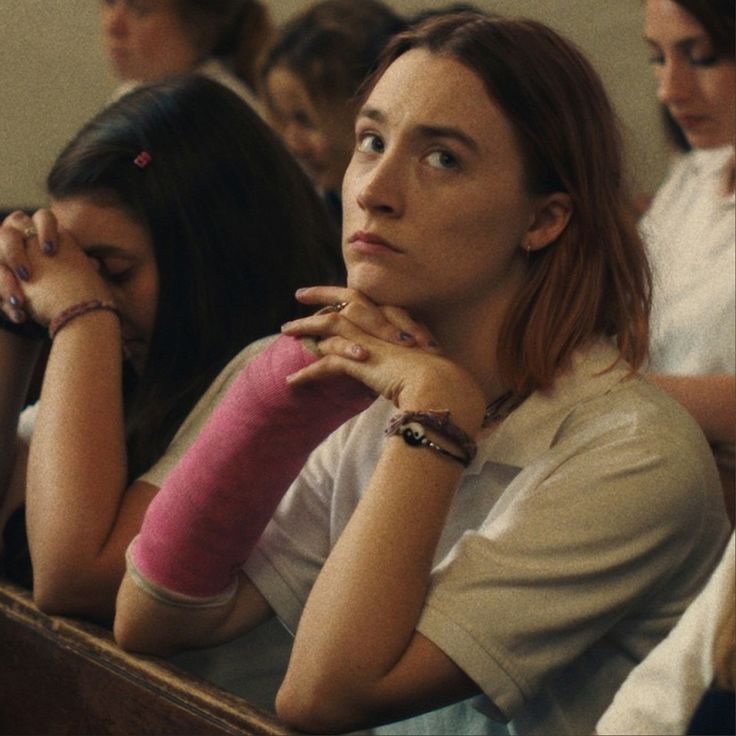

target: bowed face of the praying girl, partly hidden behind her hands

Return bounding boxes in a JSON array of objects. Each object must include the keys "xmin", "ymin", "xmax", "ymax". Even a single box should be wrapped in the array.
[{"xmin": 51, "ymin": 197, "xmax": 159, "ymax": 375}]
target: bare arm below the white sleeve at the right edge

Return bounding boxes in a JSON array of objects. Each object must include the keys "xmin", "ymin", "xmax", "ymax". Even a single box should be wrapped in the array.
[{"xmin": 649, "ymin": 373, "xmax": 736, "ymax": 443}]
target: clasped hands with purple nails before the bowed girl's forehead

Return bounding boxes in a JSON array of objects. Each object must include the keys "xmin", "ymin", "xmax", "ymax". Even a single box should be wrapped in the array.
[{"xmin": 0, "ymin": 209, "xmax": 110, "ymax": 326}]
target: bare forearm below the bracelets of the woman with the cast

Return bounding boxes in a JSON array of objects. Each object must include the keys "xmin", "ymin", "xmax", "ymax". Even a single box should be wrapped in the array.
[{"xmin": 277, "ymin": 438, "xmax": 462, "ymax": 731}]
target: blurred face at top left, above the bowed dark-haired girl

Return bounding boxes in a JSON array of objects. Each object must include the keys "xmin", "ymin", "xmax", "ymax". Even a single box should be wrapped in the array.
[{"xmin": 100, "ymin": 0, "xmax": 199, "ymax": 82}]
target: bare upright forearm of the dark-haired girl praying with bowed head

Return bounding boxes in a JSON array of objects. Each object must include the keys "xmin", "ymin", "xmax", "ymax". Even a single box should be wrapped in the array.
[{"xmin": 27, "ymin": 311, "xmax": 135, "ymax": 615}]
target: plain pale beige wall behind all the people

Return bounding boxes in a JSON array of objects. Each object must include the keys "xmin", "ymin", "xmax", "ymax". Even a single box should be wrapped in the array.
[{"xmin": 0, "ymin": 0, "xmax": 666, "ymax": 208}]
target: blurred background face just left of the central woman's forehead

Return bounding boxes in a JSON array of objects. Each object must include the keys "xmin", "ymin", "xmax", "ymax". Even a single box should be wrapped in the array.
[{"xmin": 266, "ymin": 66, "xmax": 354, "ymax": 192}]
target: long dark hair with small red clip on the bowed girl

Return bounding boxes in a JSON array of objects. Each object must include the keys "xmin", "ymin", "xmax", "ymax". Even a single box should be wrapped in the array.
[{"xmin": 47, "ymin": 76, "xmax": 344, "ymax": 479}]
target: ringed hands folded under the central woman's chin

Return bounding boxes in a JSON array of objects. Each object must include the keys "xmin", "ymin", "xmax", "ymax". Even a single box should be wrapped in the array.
[{"xmin": 282, "ymin": 286, "xmax": 485, "ymax": 435}]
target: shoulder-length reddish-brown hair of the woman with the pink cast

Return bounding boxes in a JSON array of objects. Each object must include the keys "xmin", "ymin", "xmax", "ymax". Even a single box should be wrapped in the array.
[{"xmin": 364, "ymin": 13, "xmax": 650, "ymax": 396}]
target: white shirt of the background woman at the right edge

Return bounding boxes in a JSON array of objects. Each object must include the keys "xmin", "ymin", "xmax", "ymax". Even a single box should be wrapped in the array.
[{"xmin": 641, "ymin": 146, "xmax": 736, "ymax": 375}]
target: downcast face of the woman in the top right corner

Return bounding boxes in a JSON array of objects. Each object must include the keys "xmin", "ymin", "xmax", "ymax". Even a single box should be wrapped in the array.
[{"xmin": 645, "ymin": 0, "xmax": 736, "ymax": 148}]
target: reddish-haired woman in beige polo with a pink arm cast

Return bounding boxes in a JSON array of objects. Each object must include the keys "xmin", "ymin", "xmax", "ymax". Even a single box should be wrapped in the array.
[{"xmin": 115, "ymin": 13, "xmax": 728, "ymax": 734}]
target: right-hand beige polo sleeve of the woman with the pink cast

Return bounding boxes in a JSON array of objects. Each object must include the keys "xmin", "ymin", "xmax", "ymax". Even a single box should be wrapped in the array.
[{"xmin": 418, "ymin": 398, "xmax": 726, "ymax": 718}]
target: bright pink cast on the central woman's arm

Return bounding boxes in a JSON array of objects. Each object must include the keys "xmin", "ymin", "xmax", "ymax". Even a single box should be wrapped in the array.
[{"xmin": 129, "ymin": 336, "xmax": 372, "ymax": 599}]
